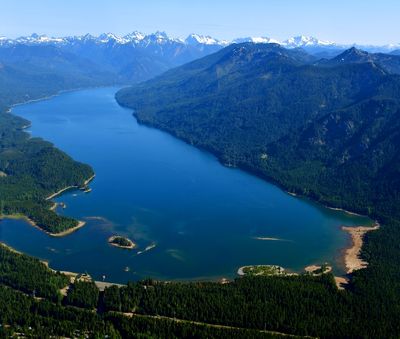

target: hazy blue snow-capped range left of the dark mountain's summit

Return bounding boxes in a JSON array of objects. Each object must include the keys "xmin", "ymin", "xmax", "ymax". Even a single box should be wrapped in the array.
[{"xmin": 0, "ymin": 32, "xmax": 222, "ymax": 87}]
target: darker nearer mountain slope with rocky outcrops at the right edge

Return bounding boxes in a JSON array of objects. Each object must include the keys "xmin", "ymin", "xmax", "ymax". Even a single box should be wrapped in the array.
[{"xmin": 258, "ymin": 95, "xmax": 400, "ymax": 220}]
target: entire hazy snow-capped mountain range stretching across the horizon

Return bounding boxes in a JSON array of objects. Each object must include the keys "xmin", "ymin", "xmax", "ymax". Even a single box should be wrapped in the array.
[{"xmin": 0, "ymin": 31, "xmax": 400, "ymax": 83}]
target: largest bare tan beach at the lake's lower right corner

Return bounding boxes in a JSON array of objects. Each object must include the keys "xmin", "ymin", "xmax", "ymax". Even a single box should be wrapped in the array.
[{"xmin": 342, "ymin": 222, "xmax": 380, "ymax": 274}]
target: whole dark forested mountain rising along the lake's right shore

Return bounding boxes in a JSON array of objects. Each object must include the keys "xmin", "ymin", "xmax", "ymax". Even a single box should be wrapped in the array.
[{"xmin": 117, "ymin": 43, "xmax": 400, "ymax": 220}]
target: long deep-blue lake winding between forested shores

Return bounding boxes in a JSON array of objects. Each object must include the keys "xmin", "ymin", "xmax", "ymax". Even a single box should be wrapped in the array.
[{"xmin": 0, "ymin": 88, "xmax": 372, "ymax": 283}]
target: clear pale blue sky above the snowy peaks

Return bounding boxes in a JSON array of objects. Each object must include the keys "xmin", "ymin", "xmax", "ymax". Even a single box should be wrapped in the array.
[{"xmin": 0, "ymin": 0, "xmax": 400, "ymax": 44}]
